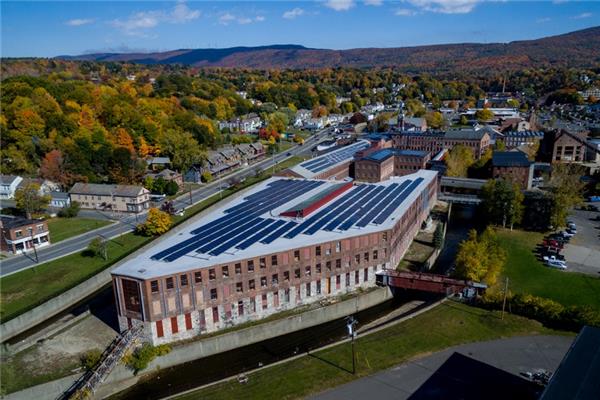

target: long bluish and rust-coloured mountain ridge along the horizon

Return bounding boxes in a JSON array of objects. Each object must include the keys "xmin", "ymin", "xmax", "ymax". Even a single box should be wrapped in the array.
[{"xmin": 56, "ymin": 26, "xmax": 600, "ymax": 72}]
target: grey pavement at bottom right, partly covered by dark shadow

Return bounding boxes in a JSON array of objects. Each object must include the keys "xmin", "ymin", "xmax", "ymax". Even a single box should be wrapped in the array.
[{"xmin": 311, "ymin": 336, "xmax": 573, "ymax": 400}]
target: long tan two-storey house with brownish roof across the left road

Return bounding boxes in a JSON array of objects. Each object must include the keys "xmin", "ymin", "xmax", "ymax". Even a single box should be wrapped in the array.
[{"xmin": 69, "ymin": 183, "xmax": 150, "ymax": 212}]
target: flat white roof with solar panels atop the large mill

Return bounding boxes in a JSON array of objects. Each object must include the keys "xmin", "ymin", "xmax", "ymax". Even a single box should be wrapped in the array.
[{"xmin": 113, "ymin": 170, "xmax": 437, "ymax": 279}]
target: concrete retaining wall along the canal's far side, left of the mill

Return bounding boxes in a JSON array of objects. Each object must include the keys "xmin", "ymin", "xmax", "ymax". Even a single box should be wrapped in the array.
[{"xmin": 0, "ymin": 186, "xmax": 260, "ymax": 342}]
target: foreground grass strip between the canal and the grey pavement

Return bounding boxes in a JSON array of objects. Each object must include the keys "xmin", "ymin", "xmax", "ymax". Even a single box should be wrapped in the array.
[{"xmin": 179, "ymin": 302, "xmax": 562, "ymax": 400}]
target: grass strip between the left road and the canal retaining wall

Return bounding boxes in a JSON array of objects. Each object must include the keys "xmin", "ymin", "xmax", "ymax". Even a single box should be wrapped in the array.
[{"xmin": 0, "ymin": 156, "xmax": 304, "ymax": 321}]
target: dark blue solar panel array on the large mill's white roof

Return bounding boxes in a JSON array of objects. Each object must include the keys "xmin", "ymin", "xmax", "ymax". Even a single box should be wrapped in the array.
[{"xmin": 151, "ymin": 178, "xmax": 423, "ymax": 262}]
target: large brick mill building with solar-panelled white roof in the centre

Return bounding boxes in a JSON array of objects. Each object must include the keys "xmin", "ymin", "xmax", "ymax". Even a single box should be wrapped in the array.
[{"xmin": 111, "ymin": 170, "xmax": 437, "ymax": 344}]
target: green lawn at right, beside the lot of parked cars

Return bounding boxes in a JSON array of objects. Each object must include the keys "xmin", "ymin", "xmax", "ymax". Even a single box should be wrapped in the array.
[{"xmin": 497, "ymin": 229, "xmax": 600, "ymax": 309}]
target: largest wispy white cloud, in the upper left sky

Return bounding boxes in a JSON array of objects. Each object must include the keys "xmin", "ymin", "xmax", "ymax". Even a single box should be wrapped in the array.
[{"xmin": 110, "ymin": 1, "xmax": 201, "ymax": 36}]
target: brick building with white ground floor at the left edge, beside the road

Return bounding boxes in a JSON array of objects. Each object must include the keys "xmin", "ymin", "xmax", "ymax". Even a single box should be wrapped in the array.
[{"xmin": 0, "ymin": 215, "xmax": 50, "ymax": 254}]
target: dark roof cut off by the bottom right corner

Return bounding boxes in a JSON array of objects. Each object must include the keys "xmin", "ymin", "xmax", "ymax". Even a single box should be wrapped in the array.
[{"xmin": 540, "ymin": 326, "xmax": 600, "ymax": 400}]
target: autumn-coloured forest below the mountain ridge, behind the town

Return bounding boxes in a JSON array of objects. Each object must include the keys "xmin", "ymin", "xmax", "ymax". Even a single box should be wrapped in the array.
[{"xmin": 0, "ymin": 59, "xmax": 598, "ymax": 186}]
